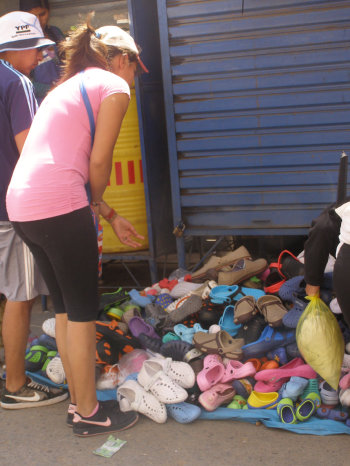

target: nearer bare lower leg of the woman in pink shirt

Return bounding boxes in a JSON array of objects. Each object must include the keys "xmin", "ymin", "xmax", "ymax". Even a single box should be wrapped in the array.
[{"xmin": 67, "ymin": 321, "xmax": 97, "ymax": 416}]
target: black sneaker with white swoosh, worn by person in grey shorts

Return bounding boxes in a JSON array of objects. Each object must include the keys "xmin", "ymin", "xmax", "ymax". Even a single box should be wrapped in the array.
[{"xmin": 0, "ymin": 377, "xmax": 68, "ymax": 409}]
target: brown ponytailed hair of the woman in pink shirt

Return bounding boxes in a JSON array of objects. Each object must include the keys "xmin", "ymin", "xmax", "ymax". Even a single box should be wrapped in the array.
[{"xmin": 58, "ymin": 13, "xmax": 109, "ymax": 84}]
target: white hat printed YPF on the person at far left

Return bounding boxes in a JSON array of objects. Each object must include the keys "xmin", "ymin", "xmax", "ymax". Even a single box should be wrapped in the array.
[{"xmin": 0, "ymin": 11, "xmax": 55, "ymax": 52}]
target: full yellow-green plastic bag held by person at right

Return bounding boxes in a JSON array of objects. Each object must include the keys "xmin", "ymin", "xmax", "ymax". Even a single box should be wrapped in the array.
[{"xmin": 296, "ymin": 296, "xmax": 344, "ymax": 390}]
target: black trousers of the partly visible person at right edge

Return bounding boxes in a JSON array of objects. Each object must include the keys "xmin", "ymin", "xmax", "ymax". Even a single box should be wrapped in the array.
[{"xmin": 333, "ymin": 244, "xmax": 350, "ymax": 328}]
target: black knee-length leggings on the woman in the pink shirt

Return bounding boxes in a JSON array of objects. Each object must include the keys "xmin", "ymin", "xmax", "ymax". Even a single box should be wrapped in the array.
[{"xmin": 12, "ymin": 207, "xmax": 99, "ymax": 322}]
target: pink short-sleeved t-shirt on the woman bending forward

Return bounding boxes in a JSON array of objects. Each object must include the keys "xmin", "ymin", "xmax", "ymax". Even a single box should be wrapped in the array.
[{"xmin": 6, "ymin": 68, "xmax": 130, "ymax": 222}]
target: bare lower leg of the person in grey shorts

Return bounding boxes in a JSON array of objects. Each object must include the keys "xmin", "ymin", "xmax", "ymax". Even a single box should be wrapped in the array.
[{"xmin": 2, "ymin": 300, "xmax": 34, "ymax": 392}]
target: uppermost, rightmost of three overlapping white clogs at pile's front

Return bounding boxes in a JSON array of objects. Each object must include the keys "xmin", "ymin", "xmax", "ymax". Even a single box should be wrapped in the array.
[{"xmin": 147, "ymin": 358, "xmax": 196, "ymax": 388}]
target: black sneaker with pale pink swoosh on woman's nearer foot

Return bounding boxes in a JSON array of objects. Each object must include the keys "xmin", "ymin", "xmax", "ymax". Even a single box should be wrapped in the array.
[{"xmin": 73, "ymin": 401, "xmax": 139, "ymax": 437}]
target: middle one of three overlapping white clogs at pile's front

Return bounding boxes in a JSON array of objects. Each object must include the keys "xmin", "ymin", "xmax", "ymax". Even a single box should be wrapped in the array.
[{"xmin": 137, "ymin": 360, "xmax": 188, "ymax": 404}]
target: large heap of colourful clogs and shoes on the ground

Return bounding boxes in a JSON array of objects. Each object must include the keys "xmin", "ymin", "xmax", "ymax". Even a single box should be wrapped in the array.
[{"xmin": 26, "ymin": 246, "xmax": 350, "ymax": 424}]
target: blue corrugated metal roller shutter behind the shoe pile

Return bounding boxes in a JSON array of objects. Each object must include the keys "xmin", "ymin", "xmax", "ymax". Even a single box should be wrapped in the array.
[{"xmin": 158, "ymin": 0, "xmax": 350, "ymax": 235}]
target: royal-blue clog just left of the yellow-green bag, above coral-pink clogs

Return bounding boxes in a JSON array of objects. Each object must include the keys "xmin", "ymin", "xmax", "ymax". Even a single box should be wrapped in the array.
[{"xmin": 242, "ymin": 325, "xmax": 295, "ymax": 358}]
